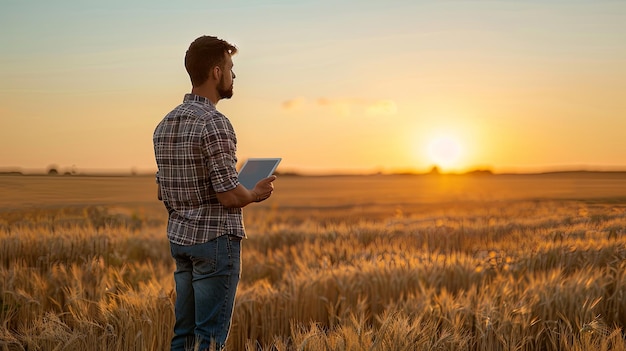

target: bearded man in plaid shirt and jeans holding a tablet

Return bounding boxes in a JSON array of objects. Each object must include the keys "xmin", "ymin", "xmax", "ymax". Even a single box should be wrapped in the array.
[{"xmin": 153, "ymin": 36, "xmax": 276, "ymax": 350}]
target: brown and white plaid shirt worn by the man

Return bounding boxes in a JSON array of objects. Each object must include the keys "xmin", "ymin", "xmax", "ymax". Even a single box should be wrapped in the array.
[{"xmin": 153, "ymin": 94, "xmax": 246, "ymax": 245}]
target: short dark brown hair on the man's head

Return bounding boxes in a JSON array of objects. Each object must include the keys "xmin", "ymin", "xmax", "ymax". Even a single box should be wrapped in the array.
[{"xmin": 185, "ymin": 35, "xmax": 237, "ymax": 87}]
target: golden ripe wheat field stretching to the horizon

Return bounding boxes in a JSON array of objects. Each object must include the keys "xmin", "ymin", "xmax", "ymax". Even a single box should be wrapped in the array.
[{"xmin": 0, "ymin": 173, "xmax": 626, "ymax": 351}]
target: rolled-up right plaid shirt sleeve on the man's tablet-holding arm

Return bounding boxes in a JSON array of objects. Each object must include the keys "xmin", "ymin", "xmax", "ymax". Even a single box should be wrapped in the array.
[{"xmin": 204, "ymin": 114, "xmax": 239, "ymax": 193}]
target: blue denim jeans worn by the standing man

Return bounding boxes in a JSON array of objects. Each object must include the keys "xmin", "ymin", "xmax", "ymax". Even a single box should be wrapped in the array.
[{"xmin": 170, "ymin": 235, "xmax": 241, "ymax": 351}]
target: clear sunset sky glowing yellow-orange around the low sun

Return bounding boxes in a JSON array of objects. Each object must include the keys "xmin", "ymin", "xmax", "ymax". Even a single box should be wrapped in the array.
[{"xmin": 0, "ymin": 0, "xmax": 626, "ymax": 174}]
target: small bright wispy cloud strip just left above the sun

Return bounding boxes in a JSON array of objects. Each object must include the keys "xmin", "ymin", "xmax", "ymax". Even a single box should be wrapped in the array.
[{"xmin": 282, "ymin": 97, "xmax": 398, "ymax": 117}]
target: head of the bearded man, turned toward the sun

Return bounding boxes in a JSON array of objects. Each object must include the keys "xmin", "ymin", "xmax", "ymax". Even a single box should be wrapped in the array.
[{"xmin": 185, "ymin": 36, "xmax": 237, "ymax": 100}]
